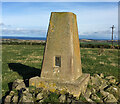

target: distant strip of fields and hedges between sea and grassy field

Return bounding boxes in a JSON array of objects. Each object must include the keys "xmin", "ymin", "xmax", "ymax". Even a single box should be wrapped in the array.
[{"xmin": 2, "ymin": 39, "xmax": 120, "ymax": 49}]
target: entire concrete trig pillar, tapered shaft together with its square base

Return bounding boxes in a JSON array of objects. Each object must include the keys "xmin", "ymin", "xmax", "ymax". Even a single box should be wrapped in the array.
[{"xmin": 29, "ymin": 12, "xmax": 90, "ymax": 97}]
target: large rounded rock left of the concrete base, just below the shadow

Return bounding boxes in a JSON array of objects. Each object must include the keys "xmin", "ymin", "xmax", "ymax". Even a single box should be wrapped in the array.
[{"xmin": 12, "ymin": 79, "xmax": 26, "ymax": 90}]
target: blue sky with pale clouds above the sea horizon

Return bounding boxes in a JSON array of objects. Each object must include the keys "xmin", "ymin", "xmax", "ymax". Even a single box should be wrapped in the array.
[{"xmin": 0, "ymin": 2, "xmax": 118, "ymax": 39}]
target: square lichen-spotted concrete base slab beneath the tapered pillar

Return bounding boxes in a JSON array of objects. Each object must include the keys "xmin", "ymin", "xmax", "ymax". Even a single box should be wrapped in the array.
[{"xmin": 29, "ymin": 74, "xmax": 90, "ymax": 97}]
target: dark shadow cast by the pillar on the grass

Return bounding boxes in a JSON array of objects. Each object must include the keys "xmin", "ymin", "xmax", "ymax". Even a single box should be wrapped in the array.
[{"xmin": 8, "ymin": 63, "xmax": 41, "ymax": 86}]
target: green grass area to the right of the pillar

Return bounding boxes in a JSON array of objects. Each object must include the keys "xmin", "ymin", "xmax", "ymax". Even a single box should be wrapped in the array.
[{"xmin": 81, "ymin": 48, "xmax": 118, "ymax": 77}]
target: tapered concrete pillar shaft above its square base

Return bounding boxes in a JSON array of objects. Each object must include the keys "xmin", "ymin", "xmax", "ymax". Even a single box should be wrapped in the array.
[{"xmin": 41, "ymin": 12, "xmax": 82, "ymax": 80}]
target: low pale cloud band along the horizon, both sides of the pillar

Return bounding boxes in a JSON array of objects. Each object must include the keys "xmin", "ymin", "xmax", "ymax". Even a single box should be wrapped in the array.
[{"xmin": 1, "ymin": 23, "xmax": 118, "ymax": 39}]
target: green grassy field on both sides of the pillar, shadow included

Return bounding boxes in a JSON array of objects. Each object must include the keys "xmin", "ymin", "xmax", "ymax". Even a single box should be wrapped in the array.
[{"xmin": 2, "ymin": 45, "xmax": 118, "ymax": 96}]
